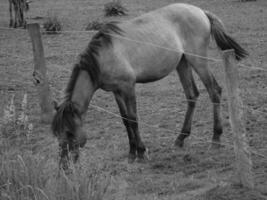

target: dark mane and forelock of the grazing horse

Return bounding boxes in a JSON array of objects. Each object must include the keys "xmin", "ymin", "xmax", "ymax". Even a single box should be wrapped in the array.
[{"xmin": 52, "ymin": 22, "xmax": 122, "ymax": 136}]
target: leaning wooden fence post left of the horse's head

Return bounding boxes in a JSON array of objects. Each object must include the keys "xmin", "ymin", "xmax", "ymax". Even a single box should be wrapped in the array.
[{"xmin": 27, "ymin": 23, "xmax": 53, "ymax": 123}]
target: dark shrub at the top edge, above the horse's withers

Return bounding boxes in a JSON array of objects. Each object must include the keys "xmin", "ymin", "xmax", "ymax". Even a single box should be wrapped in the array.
[{"xmin": 104, "ymin": 0, "xmax": 127, "ymax": 16}]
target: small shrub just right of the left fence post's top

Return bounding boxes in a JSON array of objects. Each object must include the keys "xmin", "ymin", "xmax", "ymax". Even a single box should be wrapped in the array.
[{"xmin": 43, "ymin": 15, "xmax": 62, "ymax": 34}]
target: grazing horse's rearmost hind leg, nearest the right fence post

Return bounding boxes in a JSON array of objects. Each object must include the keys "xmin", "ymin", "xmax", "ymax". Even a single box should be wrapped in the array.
[{"xmin": 190, "ymin": 55, "xmax": 223, "ymax": 146}]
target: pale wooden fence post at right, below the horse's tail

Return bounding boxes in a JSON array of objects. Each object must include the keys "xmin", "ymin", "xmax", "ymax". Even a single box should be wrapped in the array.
[{"xmin": 223, "ymin": 50, "xmax": 254, "ymax": 188}]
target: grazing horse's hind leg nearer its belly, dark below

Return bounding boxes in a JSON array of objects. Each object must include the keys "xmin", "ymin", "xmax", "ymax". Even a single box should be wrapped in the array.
[{"xmin": 175, "ymin": 56, "xmax": 199, "ymax": 147}]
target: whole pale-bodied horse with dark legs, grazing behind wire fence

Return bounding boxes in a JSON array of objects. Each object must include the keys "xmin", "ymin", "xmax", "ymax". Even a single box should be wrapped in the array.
[{"xmin": 52, "ymin": 3, "xmax": 247, "ymax": 168}]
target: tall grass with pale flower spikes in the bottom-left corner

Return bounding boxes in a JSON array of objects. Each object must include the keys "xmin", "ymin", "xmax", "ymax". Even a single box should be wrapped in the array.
[{"xmin": 0, "ymin": 94, "xmax": 110, "ymax": 200}]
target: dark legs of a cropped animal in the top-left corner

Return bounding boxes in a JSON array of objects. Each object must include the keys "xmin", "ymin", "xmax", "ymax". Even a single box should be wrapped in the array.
[{"xmin": 8, "ymin": 0, "xmax": 30, "ymax": 28}]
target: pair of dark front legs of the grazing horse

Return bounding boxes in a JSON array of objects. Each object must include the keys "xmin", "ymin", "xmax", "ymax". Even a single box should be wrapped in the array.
[{"xmin": 114, "ymin": 87, "xmax": 146, "ymax": 162}]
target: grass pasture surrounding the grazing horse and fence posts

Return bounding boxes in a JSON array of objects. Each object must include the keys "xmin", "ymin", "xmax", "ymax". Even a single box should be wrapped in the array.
[{"xmin": 0, "ymin": 0, "xmax": 267, "ymax": 200}]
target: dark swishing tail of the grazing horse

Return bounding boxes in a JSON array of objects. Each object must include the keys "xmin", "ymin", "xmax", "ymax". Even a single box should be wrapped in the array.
[{"xmin": 205, "ymin": 11, "xmax": 248, "ymax": 60}]
